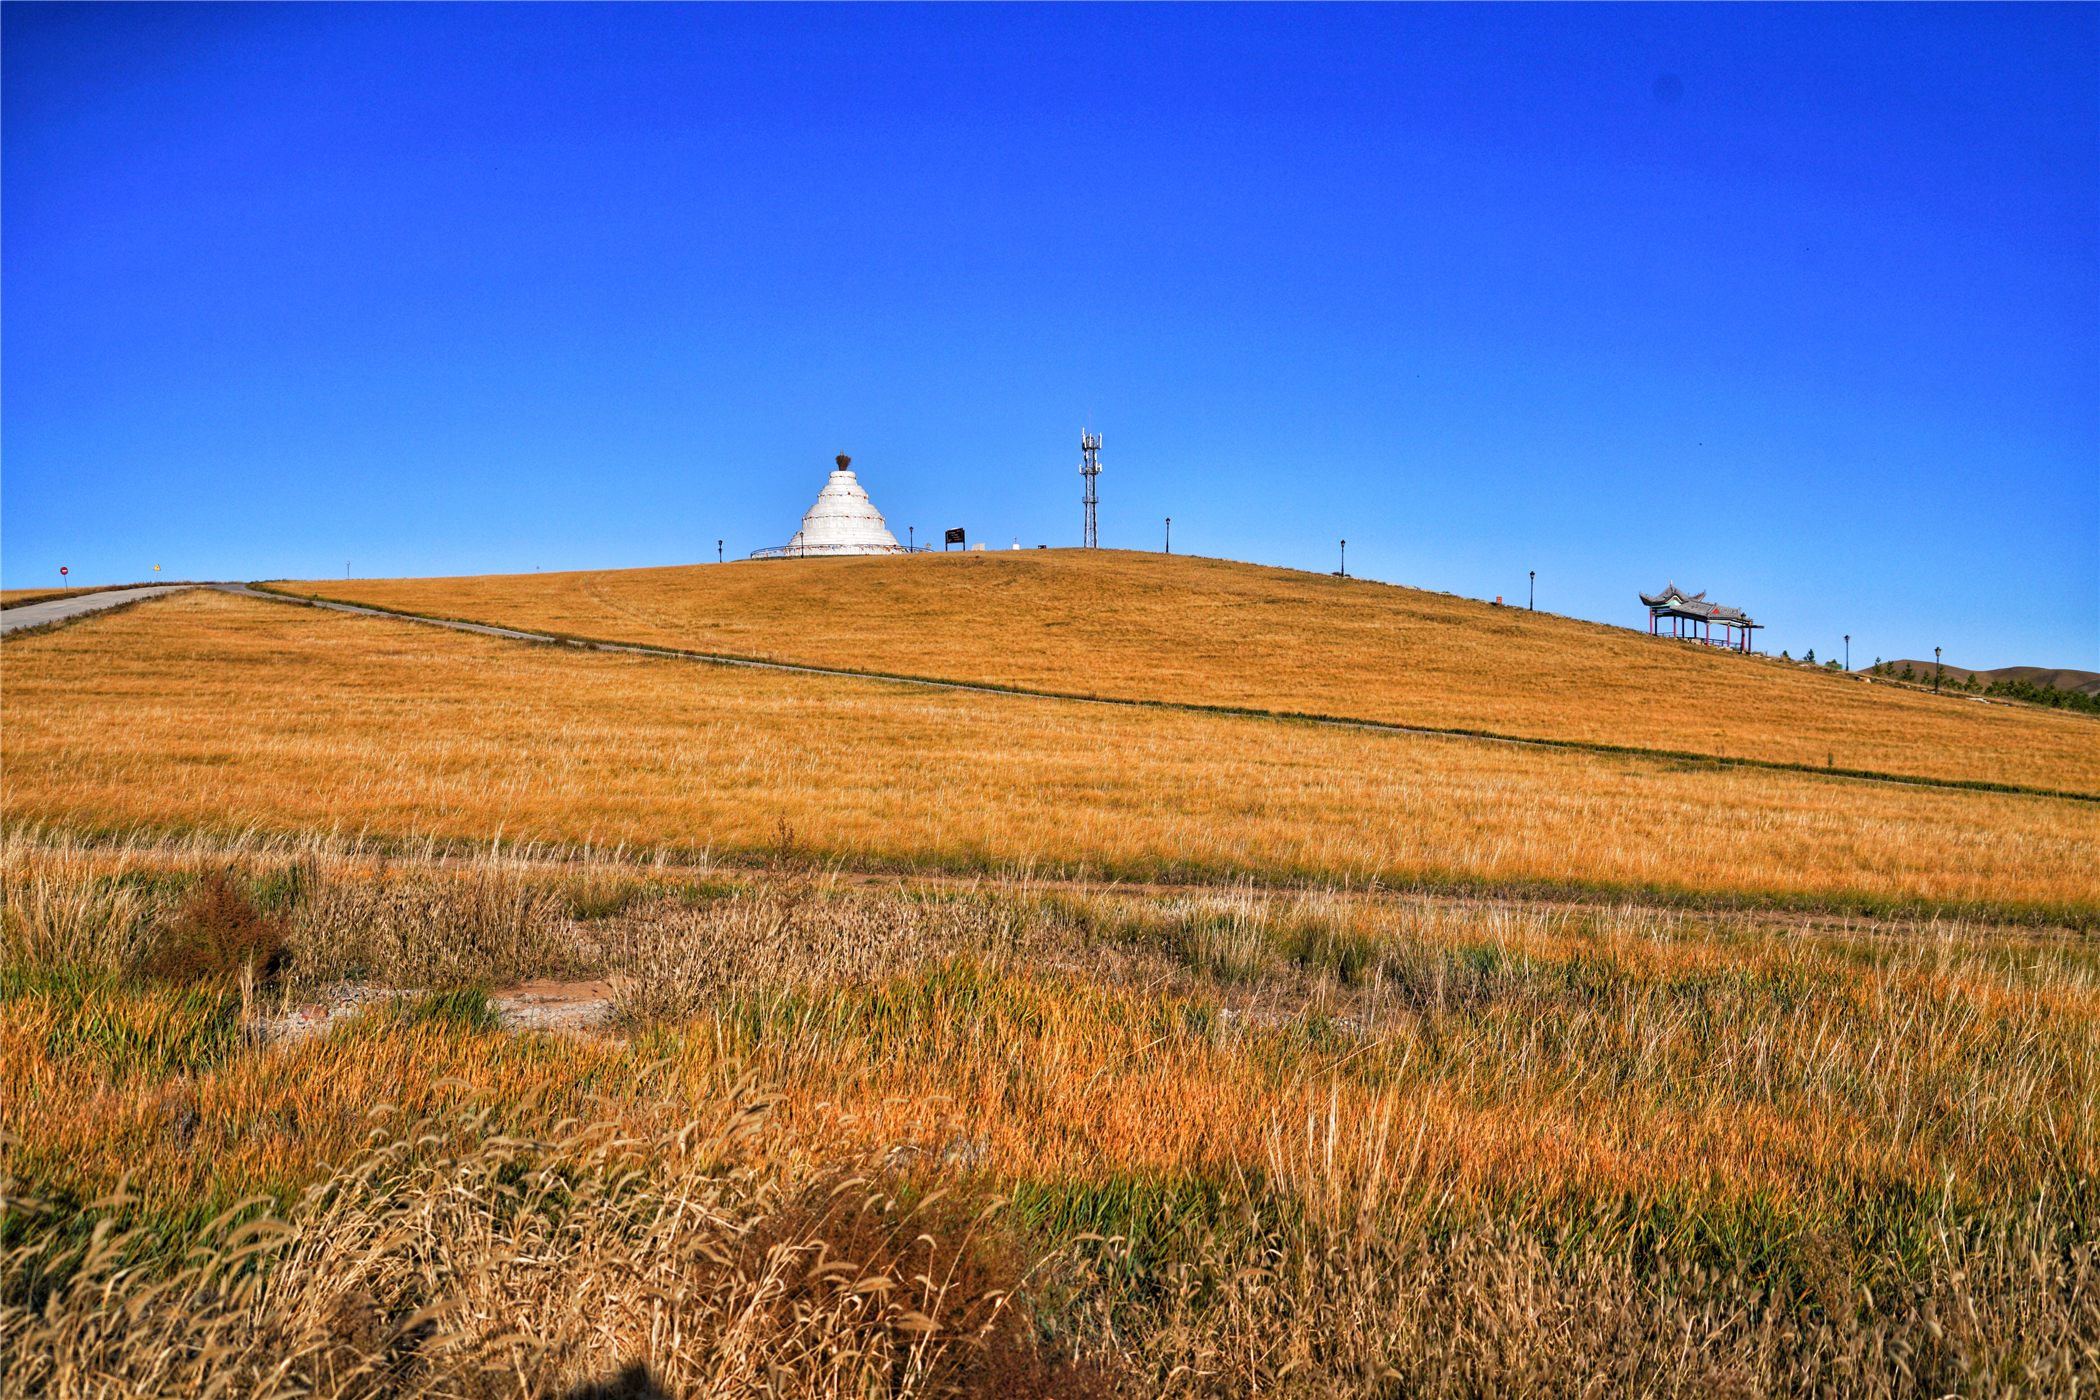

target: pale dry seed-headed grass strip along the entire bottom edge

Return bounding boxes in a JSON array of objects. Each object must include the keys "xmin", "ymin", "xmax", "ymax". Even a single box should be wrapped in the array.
[{"xmin": 0, "ymin": 1106, "xmax": 2100, "ymax": 1400}]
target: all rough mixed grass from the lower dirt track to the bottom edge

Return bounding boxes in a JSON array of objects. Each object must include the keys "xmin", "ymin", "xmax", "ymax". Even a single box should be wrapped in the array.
[{"xmin": 0, "ymin": 842, "xmax": 2100, "ymax": 1398}]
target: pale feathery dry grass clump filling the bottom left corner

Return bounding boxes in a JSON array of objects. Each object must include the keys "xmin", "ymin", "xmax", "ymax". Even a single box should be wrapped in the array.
[{"xmin": 12, "ymin": 1110, "xmax": 1086, "ymax": 1396}]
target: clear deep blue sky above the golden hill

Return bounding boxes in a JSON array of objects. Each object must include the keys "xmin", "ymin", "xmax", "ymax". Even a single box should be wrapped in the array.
[{"xmin": 0, "ymin": 4, "xmax": 2100, "ymax": 670}]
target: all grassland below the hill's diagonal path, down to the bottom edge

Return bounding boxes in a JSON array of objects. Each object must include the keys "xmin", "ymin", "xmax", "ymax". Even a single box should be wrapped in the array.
[{"xmin": 0, "ymin": 560, "xmax": 2100, "ymax": 1400}]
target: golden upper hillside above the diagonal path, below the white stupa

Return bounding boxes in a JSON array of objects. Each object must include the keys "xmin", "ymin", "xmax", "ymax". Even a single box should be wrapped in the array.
[{"xmin": 284, "ymin": 550, "xmax": 2100, "ymax": 793}]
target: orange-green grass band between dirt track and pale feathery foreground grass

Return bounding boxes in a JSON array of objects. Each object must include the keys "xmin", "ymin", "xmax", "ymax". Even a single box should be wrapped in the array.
[{"xmin": 0, "ymin": 835, "xmax": 2100, "ymax": 1222}]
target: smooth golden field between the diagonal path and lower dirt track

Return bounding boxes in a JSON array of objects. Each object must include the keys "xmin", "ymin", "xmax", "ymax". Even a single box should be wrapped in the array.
[{"xmin": 0, "ymin": 592, "xmax": 2100, "ymax": 913}]
